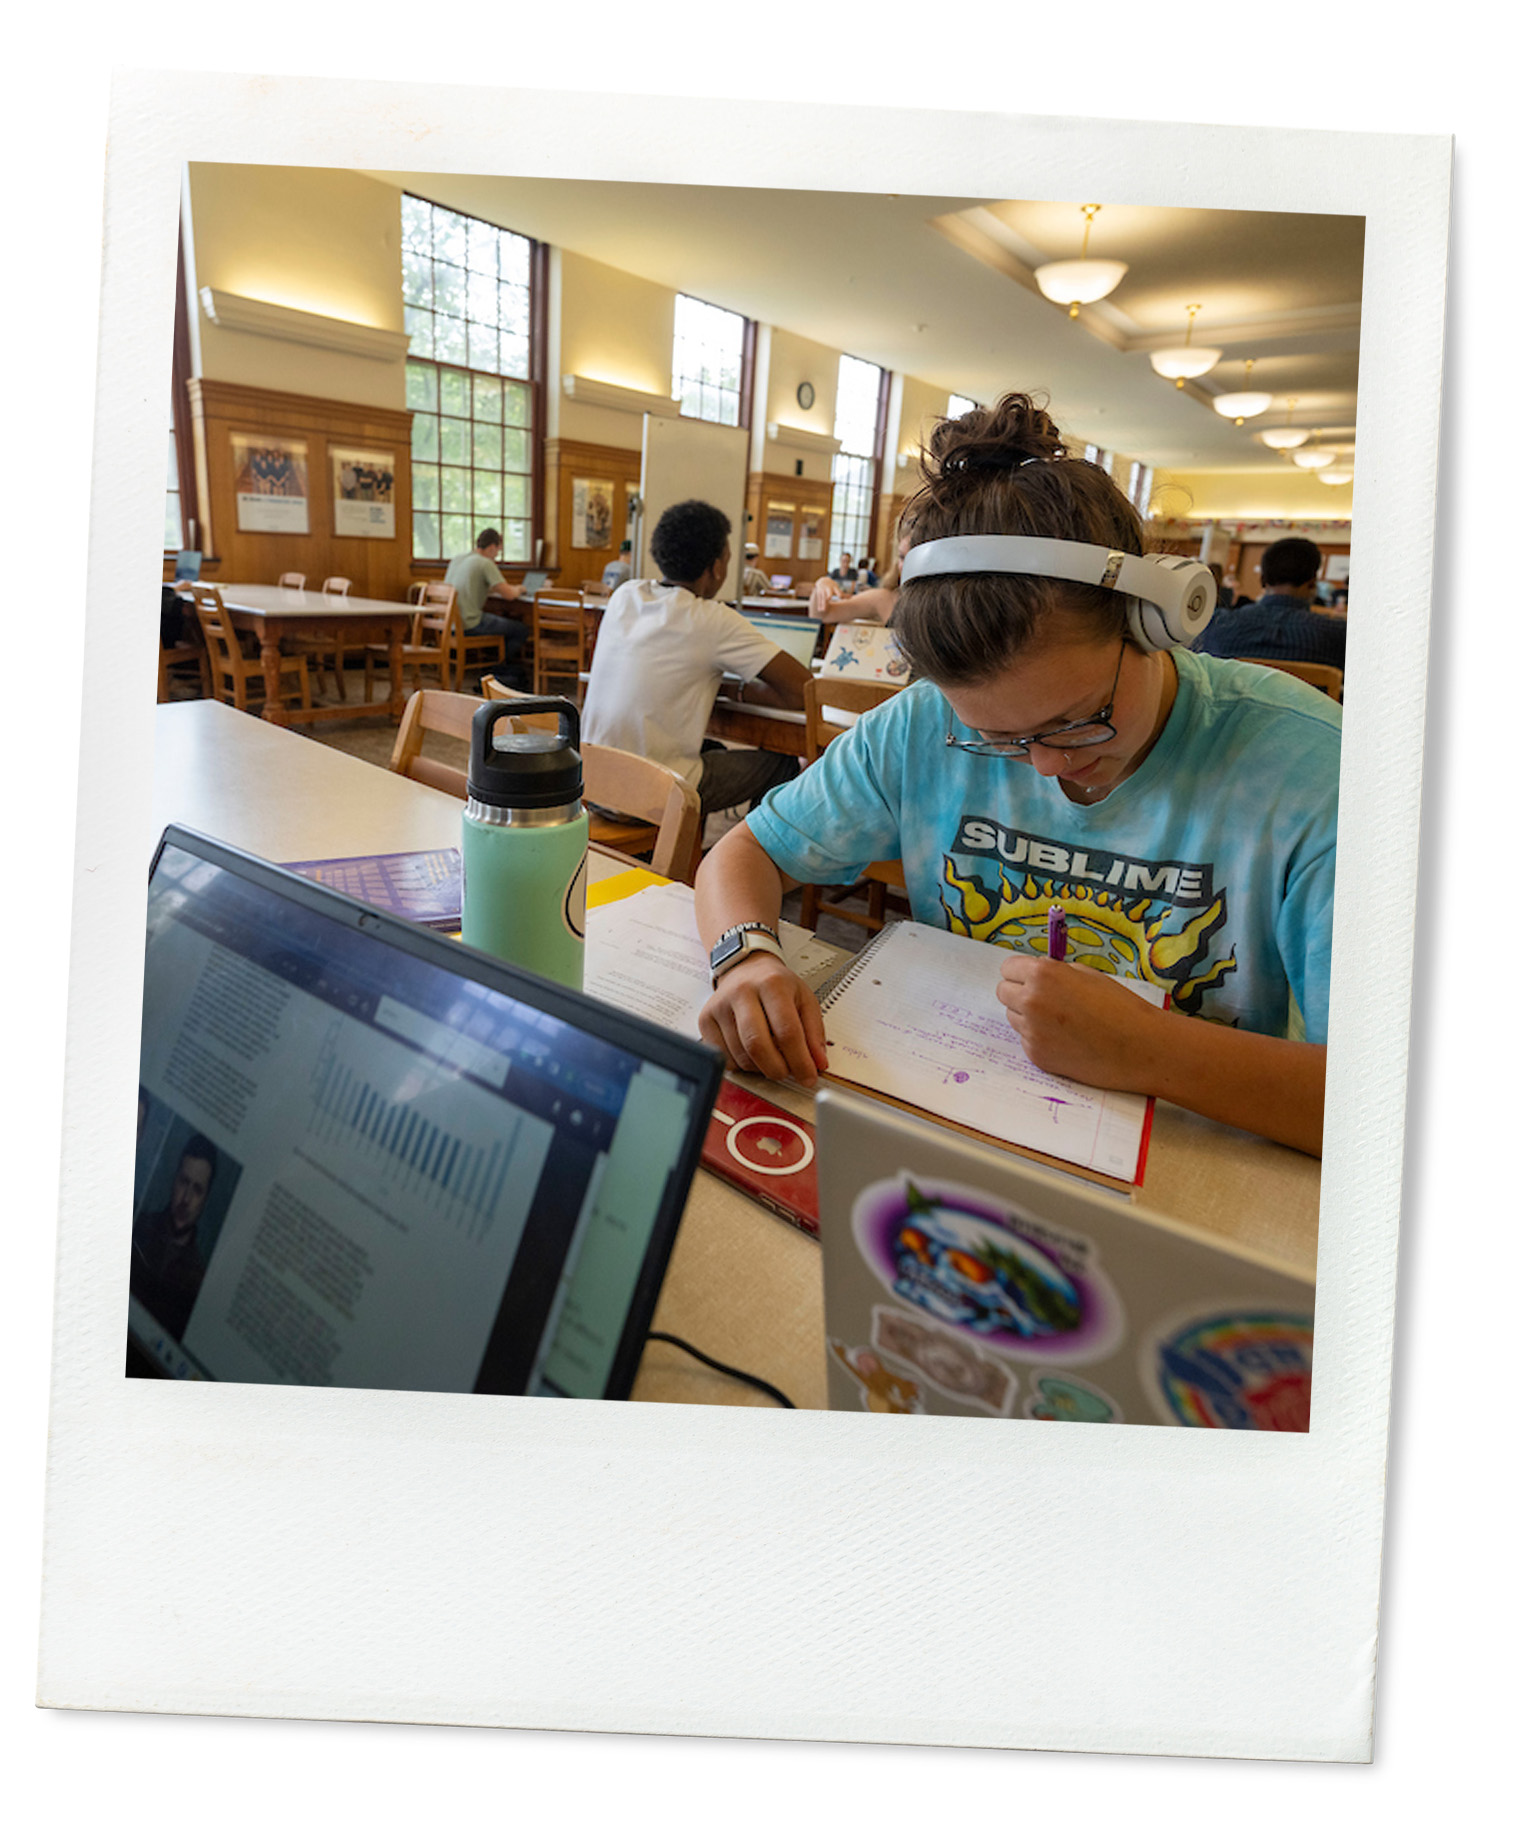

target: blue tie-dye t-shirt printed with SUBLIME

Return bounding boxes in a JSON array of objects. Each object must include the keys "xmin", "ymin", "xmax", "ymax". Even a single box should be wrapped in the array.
[{"xmin": 747, "ymin": 650, "xmax": 1342, "ymax": 1043}]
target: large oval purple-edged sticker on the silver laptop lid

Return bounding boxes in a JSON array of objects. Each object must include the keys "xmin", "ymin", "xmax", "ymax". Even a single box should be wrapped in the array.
[{"xmin": 853, "ymin": 1174, "xmax": 1125, "ymax": 1362}]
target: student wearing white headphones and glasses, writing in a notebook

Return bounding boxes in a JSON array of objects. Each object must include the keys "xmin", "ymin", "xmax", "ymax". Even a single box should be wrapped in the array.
[{"xmin": 696, "ymin": 394, "xmax": 1341, "ymax": 1152}]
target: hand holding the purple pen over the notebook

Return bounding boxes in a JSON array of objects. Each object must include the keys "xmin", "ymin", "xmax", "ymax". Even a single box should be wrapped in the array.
[{"xmin": 995, "ymin": 951, "xmax": 1167, "ymax": 1092}]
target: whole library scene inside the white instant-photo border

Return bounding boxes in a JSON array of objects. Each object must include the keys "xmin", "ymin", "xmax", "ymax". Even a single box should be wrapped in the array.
[{"xmin": 136, "ymin": 164, "xmax": 1374, "ymax": 1430}]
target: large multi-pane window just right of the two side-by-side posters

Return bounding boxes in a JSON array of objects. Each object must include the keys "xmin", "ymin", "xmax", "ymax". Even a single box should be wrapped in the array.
[{"xmin": 400, "ymin": 195, "xmax": 537, "ymax": 562}]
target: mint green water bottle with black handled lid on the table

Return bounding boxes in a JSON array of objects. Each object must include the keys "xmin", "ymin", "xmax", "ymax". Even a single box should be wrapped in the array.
[{"xmin": 462, "ymin": 698, "xmax": 590, "ymax": 990}]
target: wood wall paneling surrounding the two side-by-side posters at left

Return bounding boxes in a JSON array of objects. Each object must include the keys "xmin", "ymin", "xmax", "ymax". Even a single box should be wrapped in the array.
[{"xmin": 185, "ymin": 380, "xmax": 413, "ymax": 603}]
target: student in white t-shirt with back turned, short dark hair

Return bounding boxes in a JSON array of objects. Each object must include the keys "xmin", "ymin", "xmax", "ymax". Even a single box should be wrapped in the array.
[{"xmin": 581, "ymin": 500, "xmax": 809, "ymax": 813}]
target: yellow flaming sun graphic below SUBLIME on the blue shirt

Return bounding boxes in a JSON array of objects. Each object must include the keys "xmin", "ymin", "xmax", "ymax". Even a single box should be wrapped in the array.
[{"xmin": 941, "ymin": 856, "xmax": 1237, "ymax": 1013}]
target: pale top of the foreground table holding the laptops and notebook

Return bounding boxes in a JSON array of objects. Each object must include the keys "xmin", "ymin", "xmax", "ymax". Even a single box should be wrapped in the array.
[{"xmin": 153, "ymin": 701, "xmax": 1321, "ymax": 1408}]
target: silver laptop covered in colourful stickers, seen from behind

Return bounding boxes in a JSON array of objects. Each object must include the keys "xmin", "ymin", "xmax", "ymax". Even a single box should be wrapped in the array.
[{"xmin": 816, "ymin": 1086, "xmax": 1315, "ymax": 1432}]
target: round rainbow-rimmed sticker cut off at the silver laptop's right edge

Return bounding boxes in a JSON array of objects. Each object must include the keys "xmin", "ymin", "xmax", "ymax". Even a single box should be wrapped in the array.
[{"xmin": 1142, "ymin": 1306, "xmax": 1313, "ymax": 1433}]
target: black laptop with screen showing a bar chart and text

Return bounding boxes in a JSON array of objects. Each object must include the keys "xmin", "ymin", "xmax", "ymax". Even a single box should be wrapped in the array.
[{"xmin": 122, "ymin": 825, "xmax": 721, "ymax": 1399}]
